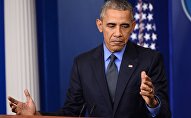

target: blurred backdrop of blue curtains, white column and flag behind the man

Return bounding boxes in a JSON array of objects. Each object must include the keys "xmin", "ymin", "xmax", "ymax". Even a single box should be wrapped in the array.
[{"xmin": 0, "ymin": 0, "xmax": 191, "ymax": 118}]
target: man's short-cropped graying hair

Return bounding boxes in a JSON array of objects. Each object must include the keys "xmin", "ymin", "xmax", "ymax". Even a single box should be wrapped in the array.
[{"xmin": 100, "ymin": 0, "xmax": 134, "ymax": 20}]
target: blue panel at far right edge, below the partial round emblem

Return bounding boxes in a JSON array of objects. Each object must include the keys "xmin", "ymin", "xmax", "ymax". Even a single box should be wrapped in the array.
[{"xmin": 169, "ymin": 0, "xmax": 191, "ymax": 118}]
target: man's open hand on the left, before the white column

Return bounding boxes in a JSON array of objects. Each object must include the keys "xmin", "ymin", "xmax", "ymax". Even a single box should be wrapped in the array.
[{"xmin": 8, "ymin": 89, "xmax": 36, "ymax": 115}]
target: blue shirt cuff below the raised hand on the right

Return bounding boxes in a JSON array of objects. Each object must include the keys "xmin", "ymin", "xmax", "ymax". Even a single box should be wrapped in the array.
[{"xmin": 146, "ymin": 96, "xmax": 161, "ymax": 117}]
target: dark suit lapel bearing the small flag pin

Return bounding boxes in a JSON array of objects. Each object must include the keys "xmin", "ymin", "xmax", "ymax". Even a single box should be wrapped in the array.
[{"xmin": 113, "ymin": 42, "xmax": 137, "ymax": 115}]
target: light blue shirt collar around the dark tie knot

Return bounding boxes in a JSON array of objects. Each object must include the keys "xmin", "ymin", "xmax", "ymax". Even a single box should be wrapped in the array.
[{"xmin": 103, "ymin": 43, "xmax": 126, "ymax": 61}]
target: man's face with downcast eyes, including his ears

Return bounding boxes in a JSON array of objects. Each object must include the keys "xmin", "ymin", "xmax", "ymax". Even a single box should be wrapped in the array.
[{"xmin": 96, "ymin": 9, "xmax": 135, "ymax": 52}]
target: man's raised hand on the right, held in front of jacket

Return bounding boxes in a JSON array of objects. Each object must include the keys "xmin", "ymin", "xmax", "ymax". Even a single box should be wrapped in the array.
[{"xmin": 140, "ymin": 71, "xmax": 159, "ymax": 108}]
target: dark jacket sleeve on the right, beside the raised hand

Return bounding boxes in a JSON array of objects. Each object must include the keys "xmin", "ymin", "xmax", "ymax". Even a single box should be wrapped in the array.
[{"xmin": 148, "ymin": 53, "xmax": 171, "ymax": 118}]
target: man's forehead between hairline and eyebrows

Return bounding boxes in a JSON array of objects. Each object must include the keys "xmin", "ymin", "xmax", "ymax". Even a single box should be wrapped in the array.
[{"xmin": 103, "ymin": 9, "xmax": 131, "ymax": 22}]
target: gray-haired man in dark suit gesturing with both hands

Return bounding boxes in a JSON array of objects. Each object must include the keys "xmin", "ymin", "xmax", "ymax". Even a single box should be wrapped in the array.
[{"xmin": 9, "ymin": 0, "xmax": 171, "ymax": 118}]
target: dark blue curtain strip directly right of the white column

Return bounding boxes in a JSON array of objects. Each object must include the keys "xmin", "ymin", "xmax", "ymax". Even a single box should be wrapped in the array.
[{"xmin": 36, "ymin": 0, "xmax": 61, "ymax": 112}]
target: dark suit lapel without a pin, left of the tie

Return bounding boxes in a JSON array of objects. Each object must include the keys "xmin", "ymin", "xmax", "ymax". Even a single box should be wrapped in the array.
[{"xmin": 92, "ymin": 45, "xmax": 112, "ymax": 111}]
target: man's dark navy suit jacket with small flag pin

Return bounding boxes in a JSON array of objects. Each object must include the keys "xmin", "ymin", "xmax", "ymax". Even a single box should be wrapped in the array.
[{"xmin": 44, "ymin": 41, "xmax": 170, "ymax": 118}]
